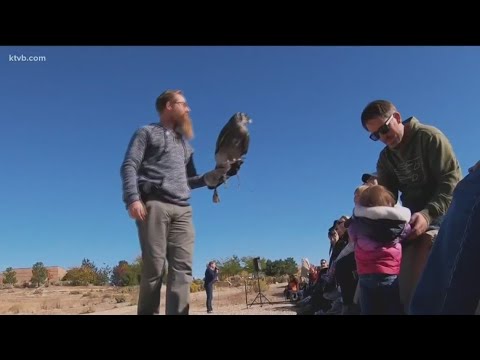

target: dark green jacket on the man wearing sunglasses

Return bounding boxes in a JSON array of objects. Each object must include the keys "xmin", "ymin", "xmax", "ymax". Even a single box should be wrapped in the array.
[{"xmin": 377, "ymin": 117, "xmax": 462, "ymax": 224}]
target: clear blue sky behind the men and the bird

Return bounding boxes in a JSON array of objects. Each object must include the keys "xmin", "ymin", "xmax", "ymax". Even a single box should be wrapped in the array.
[{"xmin": 0, "ymin": 46, "xmax": 480, "ymax": 277}]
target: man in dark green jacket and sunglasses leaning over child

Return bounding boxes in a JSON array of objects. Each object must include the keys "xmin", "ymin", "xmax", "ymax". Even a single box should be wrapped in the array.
[{"xmin": 361, "ymin": 100, "xmax": 461, "ymax": 312}]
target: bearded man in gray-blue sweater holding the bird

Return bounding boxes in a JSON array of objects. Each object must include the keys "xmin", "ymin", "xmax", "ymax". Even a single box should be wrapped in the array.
[{"xmin": 121, "ymin": 90, "xmax": 228, "ymax": 315}]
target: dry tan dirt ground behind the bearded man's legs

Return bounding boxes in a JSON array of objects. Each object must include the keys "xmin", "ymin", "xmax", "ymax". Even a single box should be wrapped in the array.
[{"xmin": 0, "ymin": 284, "xmax": 295, "ymax": 315}]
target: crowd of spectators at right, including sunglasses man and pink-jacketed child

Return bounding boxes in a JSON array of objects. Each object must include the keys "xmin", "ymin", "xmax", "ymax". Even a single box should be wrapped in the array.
[{"xmin": 288, "ymin": 100, "xmax": 480, "ymax": 315}]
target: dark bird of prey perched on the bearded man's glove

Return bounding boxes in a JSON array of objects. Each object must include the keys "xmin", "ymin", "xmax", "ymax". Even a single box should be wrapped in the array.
[{"xmin": 210, "ymin": 112, "xmax": 252, "ymax": 203}]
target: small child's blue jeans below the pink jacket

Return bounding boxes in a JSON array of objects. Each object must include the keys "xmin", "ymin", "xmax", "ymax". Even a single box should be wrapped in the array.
[{"xmin": 359, "ymin": 274, "xmax": 403, "ymax": 315}]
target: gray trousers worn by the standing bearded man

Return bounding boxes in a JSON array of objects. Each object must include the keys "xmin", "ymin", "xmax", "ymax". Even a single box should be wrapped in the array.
[{"xmin": 137, "ymin": 200, "xmax": 195, "ymax": 315}]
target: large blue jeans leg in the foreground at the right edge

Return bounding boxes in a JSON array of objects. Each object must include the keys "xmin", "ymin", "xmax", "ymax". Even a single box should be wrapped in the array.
[{"xmin": 410, "ymin": 171, "xmax": 480, "ymax": 315}]
